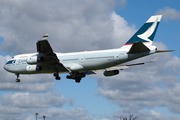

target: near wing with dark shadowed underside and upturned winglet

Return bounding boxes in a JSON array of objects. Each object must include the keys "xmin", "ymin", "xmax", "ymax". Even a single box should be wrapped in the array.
[{"xmin": 36, "ymin": 34, "xmax": 70, "ymax": 72}]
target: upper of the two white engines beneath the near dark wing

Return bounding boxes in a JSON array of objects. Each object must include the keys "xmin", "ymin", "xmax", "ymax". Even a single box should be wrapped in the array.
[{"xmin": 27, "ymin": 56, "xmax": 44, "ymax": 64}]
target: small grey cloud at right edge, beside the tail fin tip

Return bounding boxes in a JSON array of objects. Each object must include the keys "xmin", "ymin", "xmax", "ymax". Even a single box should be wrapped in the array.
[{"xmin": 156, "ymin": 7, "xmax": 180, "ymax": 20}]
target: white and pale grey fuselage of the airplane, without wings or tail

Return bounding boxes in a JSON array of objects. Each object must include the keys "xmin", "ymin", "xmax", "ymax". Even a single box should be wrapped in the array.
[{"xmin": 4, "ymin": 46, "xmax": 156, "ymax": 74}]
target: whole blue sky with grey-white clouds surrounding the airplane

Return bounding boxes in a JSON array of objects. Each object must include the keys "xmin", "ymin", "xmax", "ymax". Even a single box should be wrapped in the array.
[{"xmin": 0, "ymin": 0, "xmax": 180, "ymax": 120}]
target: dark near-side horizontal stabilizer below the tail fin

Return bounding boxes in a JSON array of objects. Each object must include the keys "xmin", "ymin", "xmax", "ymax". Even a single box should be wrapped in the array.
[{"xmin": 127, "ymin": 42, "xmax": 150, "ymax": 54}]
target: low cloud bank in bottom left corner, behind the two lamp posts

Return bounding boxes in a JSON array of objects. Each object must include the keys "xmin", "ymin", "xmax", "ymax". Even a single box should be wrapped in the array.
[{"xmin": 0, "ymin": 93, "xmax": 95, "ymax": 120}]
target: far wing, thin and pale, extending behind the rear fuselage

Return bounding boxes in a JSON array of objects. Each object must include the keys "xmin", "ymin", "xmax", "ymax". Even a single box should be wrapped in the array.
[{"xmin": 89, "ymin": 57, "xmax": 158, "ymax": 74}]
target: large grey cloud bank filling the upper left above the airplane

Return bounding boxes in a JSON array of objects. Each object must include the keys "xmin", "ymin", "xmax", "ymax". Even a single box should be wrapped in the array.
[{"xmin": 0, "ymin": 0, "xmax": 131, "ymax": 55}]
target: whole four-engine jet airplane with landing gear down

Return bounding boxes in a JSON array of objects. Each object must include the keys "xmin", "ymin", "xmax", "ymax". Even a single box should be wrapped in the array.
[{"xmin": 4, "ymin": 15, "xmax": 173, "ymax": 83}]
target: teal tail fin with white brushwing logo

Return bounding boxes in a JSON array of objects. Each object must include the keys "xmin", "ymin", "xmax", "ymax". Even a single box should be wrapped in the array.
[{"xmin": 125, "ymin": 15, "xmax": 162, "ymax": 45}]
